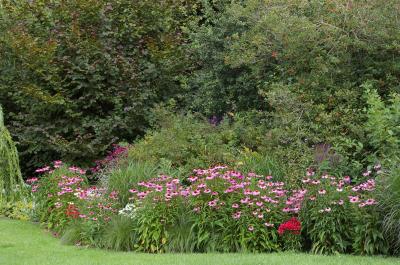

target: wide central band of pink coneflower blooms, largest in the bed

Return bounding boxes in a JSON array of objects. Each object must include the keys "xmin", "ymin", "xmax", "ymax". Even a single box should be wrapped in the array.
[{"xmin": 129, "ymin": 166, "xmax": 307, "ymax": 227}]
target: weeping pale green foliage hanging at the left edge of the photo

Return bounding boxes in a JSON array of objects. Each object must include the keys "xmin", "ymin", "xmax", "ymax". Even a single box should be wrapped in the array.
[{"xmin": 0, "ymin": 106, "xmax": 24, "ymax": 202}]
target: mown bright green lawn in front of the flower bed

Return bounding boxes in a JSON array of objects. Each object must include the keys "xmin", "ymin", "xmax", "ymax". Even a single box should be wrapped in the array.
[{"xmin": 0, "ymin": 218, "xmax": 400, "ymax": 265}]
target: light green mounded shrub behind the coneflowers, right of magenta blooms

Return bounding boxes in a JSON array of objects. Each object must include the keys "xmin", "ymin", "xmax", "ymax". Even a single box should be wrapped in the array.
[{"xmin": 128, "ymin": 109, "xmax": 238, "ymax": 175}]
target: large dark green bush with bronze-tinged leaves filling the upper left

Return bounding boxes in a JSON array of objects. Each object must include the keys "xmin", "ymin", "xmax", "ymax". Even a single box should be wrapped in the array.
[{"xmin": 0, "ymin": 0, "xmax": 196, "ymax": 174}]
